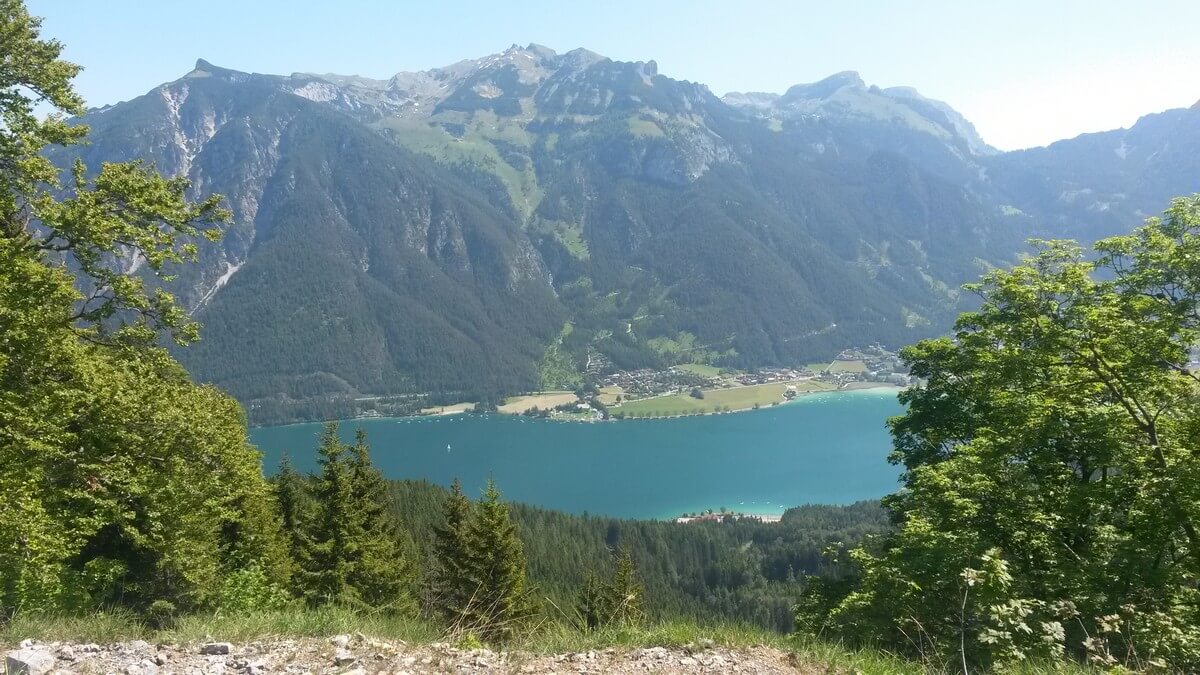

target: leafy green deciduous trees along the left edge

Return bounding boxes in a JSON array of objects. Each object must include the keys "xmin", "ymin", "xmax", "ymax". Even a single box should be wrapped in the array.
[{"xmin": 0, "ymin": 0, "xmax": 288, "ymax": 611}]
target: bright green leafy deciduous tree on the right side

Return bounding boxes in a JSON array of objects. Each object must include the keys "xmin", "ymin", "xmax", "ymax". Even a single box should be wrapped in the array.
[{"xmin": 802, "ymin": 196, "xmax": 1200, "ymax": 670}]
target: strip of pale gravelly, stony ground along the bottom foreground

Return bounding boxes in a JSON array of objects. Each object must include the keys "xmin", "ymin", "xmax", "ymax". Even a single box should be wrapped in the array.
[{"xmin": 6, "ymin": 634, "xmax": 823, "ymax": 675}]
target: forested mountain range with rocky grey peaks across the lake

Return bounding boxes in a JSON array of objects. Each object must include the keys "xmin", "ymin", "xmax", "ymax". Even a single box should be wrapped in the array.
[{"xmin": 63, "ymin": 44, "xmax": 1200, "ymax": 422}]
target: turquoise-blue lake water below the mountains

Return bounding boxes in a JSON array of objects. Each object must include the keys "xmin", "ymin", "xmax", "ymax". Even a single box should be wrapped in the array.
[{"xmin": 251, "ymin": 389, "xmax": 902, "ymax": 518}]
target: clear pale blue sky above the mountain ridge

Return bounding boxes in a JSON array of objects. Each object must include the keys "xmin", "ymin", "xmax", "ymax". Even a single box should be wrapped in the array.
[{"xmin": 28, "ymin": 0, "xmax": 1200, "ymax": 149}]
